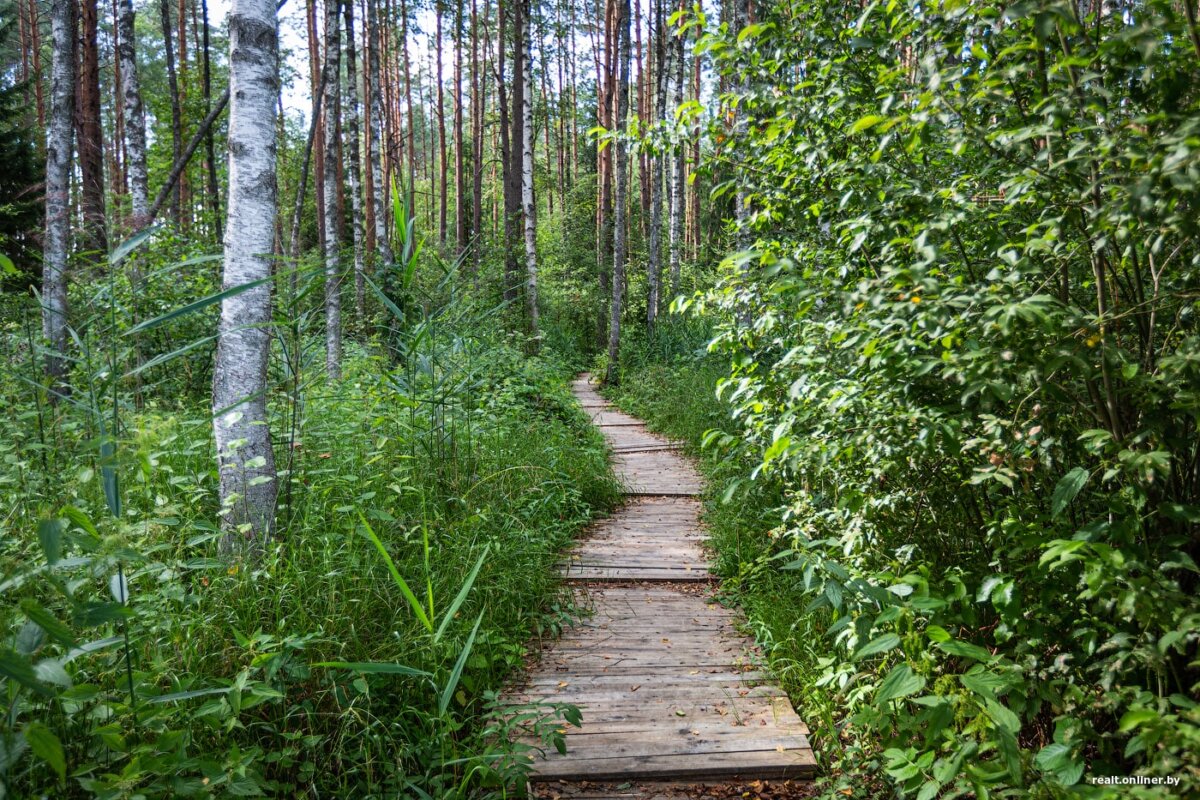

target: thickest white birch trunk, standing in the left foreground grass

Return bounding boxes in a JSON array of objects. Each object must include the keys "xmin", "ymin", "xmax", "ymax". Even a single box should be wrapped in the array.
[{"xmin": 212, "ymin": 0, "xmax": 278, "ymax": 552}]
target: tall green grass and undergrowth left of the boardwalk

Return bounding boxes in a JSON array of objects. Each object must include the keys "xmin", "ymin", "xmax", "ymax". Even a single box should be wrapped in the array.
[{"xmin": 0, "ymin": 224, "xmax": 619, "ymax": 798}]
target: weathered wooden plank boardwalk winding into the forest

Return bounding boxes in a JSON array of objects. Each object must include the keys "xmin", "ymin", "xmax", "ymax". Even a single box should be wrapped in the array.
[{"xmin": 508, "ymin": 377, "xmax": 815, "ymax": 787}]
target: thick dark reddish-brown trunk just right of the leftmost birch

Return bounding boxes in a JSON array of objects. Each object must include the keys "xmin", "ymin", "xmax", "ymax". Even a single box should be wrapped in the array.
[{"xmin": 76, "ymin": 0, "xmax": 108, "ymax": 253}]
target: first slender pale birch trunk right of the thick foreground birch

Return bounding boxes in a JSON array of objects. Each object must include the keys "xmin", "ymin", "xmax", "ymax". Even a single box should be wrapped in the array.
[{"xmin": 322, "ymin": 0, "xmax": 342, "ymax": 380}]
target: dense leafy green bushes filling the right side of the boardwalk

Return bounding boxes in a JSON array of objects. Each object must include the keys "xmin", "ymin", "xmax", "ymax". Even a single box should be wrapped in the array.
[{"xmin": 652, "ymin": 0, "xmax": 1200, "ymax": 799}]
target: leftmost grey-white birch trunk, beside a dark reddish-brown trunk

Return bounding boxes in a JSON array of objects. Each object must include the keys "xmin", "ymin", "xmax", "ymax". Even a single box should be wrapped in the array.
[{"xmin": 42, "ymin": 0, "xmax": 76, "ymax": 398}]
